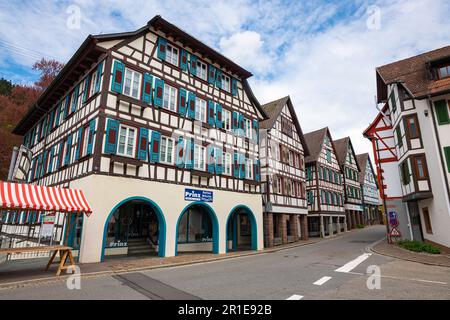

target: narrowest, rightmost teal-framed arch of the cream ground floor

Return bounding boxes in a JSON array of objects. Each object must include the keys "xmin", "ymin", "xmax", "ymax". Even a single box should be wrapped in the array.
[{"xmin": 226, "ymin": 205, "xmax": 258, "ymax": 252}]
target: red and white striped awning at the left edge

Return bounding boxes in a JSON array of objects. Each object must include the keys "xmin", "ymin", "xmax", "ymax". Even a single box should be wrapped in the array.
[{"xmin": 0, "ymin": 181, "xmax": 92, "ymax": 216}]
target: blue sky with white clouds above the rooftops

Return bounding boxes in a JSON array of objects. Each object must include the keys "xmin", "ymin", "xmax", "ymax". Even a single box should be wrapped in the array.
[{"xmin": 0, "ymin": 0, "xmax": 450, "ymax": 159}]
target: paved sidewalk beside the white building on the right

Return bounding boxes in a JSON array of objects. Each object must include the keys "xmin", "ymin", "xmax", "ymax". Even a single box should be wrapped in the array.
[{"xmin": 371, "ymin": 240, "xmax": 450, "ymax": 267}]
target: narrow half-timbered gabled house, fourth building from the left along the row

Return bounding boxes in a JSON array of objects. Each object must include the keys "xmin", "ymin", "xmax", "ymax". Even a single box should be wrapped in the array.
[{"xmin": 334, "ymin": 137, "xmax": 364, "ymax": 229}]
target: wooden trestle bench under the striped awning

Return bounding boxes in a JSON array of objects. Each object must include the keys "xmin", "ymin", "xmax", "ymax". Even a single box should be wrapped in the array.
[{"xmin": 0, "ymin": 245, "xmax": 75, "ymax": 276}]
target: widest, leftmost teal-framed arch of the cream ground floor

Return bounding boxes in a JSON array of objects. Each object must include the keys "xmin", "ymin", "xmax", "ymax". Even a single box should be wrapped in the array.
[{"xmin": 101, "ymin": 197, "xmax": 166, "ymax": 261}]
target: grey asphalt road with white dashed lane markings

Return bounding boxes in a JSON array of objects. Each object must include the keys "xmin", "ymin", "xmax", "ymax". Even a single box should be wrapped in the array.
[{"xmin": 0, "ymin": 226, "xmax": 450, "ymax": 300}]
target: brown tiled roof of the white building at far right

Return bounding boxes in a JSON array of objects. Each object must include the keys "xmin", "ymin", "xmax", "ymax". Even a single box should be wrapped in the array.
[{"xmin": 376, "ymin": 46, "xmax": 450, "ymax": 103}]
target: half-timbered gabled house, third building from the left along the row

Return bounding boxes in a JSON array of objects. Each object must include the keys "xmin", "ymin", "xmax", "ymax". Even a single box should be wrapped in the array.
[{"xmin": 305, "ymin": 127, "xmax": 347, "ymax": 237}]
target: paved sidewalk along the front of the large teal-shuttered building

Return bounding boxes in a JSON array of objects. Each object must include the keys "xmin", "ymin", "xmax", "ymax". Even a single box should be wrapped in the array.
[{"xmin": 0, "ymin": 233, "xmax": 324, "ymax": 290}]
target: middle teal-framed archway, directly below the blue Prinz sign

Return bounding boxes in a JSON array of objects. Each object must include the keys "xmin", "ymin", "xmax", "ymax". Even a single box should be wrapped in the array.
[{"xmin": 175, "ymin": 202, "xmax": 219, "ymax": 255}]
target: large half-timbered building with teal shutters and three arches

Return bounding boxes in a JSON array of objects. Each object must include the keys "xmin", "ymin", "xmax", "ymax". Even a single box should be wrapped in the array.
[{"xmin": 14, "ymin": 16, "xmax": 266, "ymax": 262}]
